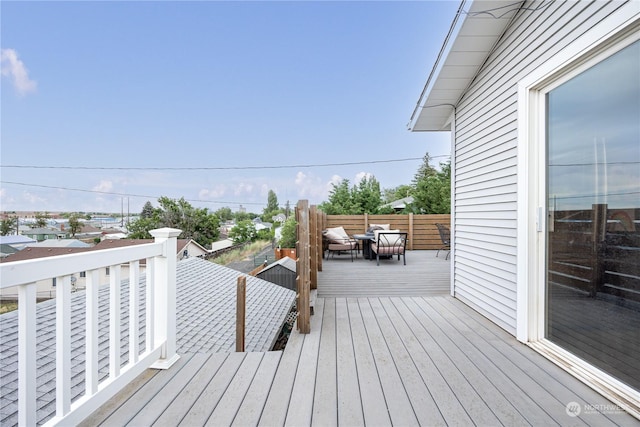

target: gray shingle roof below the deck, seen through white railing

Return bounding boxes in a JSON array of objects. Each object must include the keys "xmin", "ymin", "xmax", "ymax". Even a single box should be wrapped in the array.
[{"xmin": 0, "ymin": 258, "xmax": 295, "ymax": 426}]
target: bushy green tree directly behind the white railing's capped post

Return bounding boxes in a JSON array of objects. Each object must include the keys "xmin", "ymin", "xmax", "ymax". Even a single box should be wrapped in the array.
[{"xmin": 128, "ymin": 196, "xmax": 220, "ymax": 247}]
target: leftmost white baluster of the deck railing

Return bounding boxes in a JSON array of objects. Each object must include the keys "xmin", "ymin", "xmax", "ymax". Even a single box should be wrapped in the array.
[{"xmin": 18, "ymin": 283, "xmax": 36, "ymax": 426}]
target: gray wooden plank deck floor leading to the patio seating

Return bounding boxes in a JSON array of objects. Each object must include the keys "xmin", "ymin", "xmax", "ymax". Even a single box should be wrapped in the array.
[{"xmin": 83, "ymin": 252, "xmax": 638, "ymax": 426}]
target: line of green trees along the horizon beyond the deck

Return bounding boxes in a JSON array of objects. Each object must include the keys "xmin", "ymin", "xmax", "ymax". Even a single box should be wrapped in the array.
[{"xmin": 0, "ymin": 153, "xmax": 451, "ymax": 247}]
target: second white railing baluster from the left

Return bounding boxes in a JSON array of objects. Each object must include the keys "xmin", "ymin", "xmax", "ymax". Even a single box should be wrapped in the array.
[{"xmin": 56, "ymin": 275, "xmax": 71, "ymax": 417}]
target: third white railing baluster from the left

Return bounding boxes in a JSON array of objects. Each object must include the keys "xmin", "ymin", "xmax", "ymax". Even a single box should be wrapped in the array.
[{"xmin": 85, "ymin": 270, "xmax": 100, "ymax": 396}]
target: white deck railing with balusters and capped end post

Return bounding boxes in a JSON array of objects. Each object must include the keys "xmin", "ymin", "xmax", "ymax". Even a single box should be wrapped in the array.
[{"xmin": 0, "ymin": 228, "xmax": 181, "ymax": 426}]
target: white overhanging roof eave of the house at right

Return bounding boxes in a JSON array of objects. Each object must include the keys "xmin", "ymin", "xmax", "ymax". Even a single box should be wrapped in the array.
[{"xmin": 409, "ymin": 0, "xmax": 524, "ymax": 132}]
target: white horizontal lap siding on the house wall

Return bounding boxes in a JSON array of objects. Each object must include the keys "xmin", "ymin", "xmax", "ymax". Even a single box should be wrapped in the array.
[{"xmin": 454, "ymin": 1, "xmax": 629, "ymax": 335}]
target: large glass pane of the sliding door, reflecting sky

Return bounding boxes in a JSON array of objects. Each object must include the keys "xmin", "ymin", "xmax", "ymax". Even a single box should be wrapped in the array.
[{"xmin": 544, "ymin": 41, "xmax": 640, "ymax": 390}]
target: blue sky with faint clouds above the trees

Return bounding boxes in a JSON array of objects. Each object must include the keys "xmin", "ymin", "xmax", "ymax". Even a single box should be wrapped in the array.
[{"xmin": 0, "ymin": 1, "xmax": 459, "ymax": 212}]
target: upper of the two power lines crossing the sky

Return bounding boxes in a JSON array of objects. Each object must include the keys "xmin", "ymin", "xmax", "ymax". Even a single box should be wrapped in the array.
[{"xmin": 0, "ymin": 154, "xmax": 450, "ymax": 171}]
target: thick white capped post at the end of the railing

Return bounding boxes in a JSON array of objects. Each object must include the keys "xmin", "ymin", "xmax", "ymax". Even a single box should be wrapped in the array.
[{"xmin": 147, "ymin": 228, "xmax": 182, "ymax": 369}]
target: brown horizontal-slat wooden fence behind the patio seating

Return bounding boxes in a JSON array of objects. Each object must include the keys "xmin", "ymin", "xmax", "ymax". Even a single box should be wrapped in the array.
[{"xmin": 321, "ymin": 214, "xmax": 451, "ymax": 250}]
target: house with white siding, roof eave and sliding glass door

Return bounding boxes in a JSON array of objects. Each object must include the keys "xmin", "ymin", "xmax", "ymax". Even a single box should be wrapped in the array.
[{"xmin": 409, "ymin": 1, "xmax": 640, "ymax": 413}]
